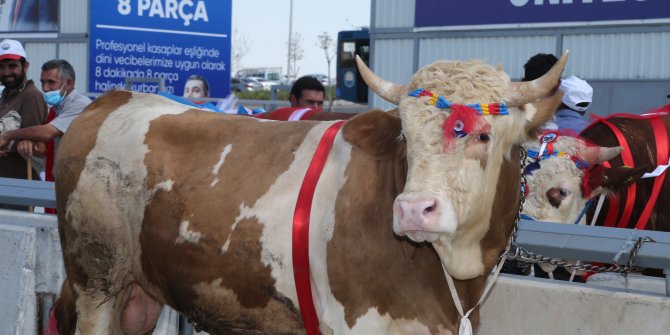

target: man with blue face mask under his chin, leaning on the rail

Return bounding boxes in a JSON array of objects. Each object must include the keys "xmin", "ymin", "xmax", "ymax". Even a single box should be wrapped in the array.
[{"xmin": 0, "ymin": 59, "xmax": 91, "ymax": 181}]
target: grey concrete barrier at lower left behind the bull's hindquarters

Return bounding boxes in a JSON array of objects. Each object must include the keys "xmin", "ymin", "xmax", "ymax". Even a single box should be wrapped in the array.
[{"xmin": 0, "ymin": 210, "xmax": 65, "ymax": 335}]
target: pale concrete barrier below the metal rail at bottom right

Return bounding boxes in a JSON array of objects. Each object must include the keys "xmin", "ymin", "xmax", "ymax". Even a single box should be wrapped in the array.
[{"xmin": 478, "ymin": 275, "xmax": 670, "ymax": 335}]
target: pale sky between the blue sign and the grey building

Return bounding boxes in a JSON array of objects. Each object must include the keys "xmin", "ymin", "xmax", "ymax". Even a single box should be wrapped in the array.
[{"xmin": 231, "ymin": 0, "xmax": 370, "ymax": 77}]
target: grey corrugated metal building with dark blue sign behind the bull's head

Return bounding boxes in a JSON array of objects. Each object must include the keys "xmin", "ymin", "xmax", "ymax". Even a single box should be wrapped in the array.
[{"xmin": 369, "ymin": 0, "xmax": 670, "ymax": 115}]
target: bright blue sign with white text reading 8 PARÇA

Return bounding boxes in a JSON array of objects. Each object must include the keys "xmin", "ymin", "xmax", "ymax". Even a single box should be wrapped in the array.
[{"xmin": 88, "ymin": 0, "xmax": 232, "ymax": 97}]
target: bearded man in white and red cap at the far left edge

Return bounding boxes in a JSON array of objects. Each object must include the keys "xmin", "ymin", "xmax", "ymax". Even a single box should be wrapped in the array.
[{"xmin": 0, "ymin": 39, "xmax": 47, "ymax": 209}]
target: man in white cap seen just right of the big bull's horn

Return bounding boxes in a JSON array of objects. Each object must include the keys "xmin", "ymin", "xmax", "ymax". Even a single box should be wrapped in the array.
[{"xmin": 556, "ymin": 76, "xmax": 593, "ymax": 133}]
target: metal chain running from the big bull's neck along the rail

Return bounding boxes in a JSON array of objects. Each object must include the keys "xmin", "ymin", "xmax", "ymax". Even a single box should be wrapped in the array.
[{"xmin": 499, "ymin": 146, "xmax": 655, "ymax": 274}]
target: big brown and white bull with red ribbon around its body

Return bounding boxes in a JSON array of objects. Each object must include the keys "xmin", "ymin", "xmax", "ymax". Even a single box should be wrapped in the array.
[{"xmin": 56, "ymin": 55, "xmax": 567, "ymax": 335}]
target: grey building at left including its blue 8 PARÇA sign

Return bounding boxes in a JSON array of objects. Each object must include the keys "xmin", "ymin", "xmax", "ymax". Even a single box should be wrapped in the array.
[{"xmin": 0, "ymin": 0, "xmax": 232, "ymax": 98}]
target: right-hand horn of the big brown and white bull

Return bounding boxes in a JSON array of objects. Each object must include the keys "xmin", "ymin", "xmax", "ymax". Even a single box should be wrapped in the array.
[{"xmin": 503, "ymin": 51, "xmax": 569, "ymax": 107}]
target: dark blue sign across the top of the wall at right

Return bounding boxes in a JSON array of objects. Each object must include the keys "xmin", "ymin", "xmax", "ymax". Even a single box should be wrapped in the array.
[{"xmin": 414, "ymin": 0, "xmax": 670, "ymax": 27}]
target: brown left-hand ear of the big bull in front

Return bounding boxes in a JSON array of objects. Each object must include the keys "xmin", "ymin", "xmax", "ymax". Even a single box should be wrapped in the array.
[{"xmin": 342, "ymin": 111, "xmax": 402, "ymax": 158}]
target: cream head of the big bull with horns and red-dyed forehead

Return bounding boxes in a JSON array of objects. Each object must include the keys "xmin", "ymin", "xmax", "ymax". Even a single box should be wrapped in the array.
[{"xmin": 357, "ymin": 53, "xmax": 567, "ymax": 279}]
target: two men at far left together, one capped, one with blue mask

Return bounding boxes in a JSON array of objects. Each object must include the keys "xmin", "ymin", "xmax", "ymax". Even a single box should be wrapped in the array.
[{"xmin": 0, "ymin": 39, "xmax": 91, "ymax": 210}]
